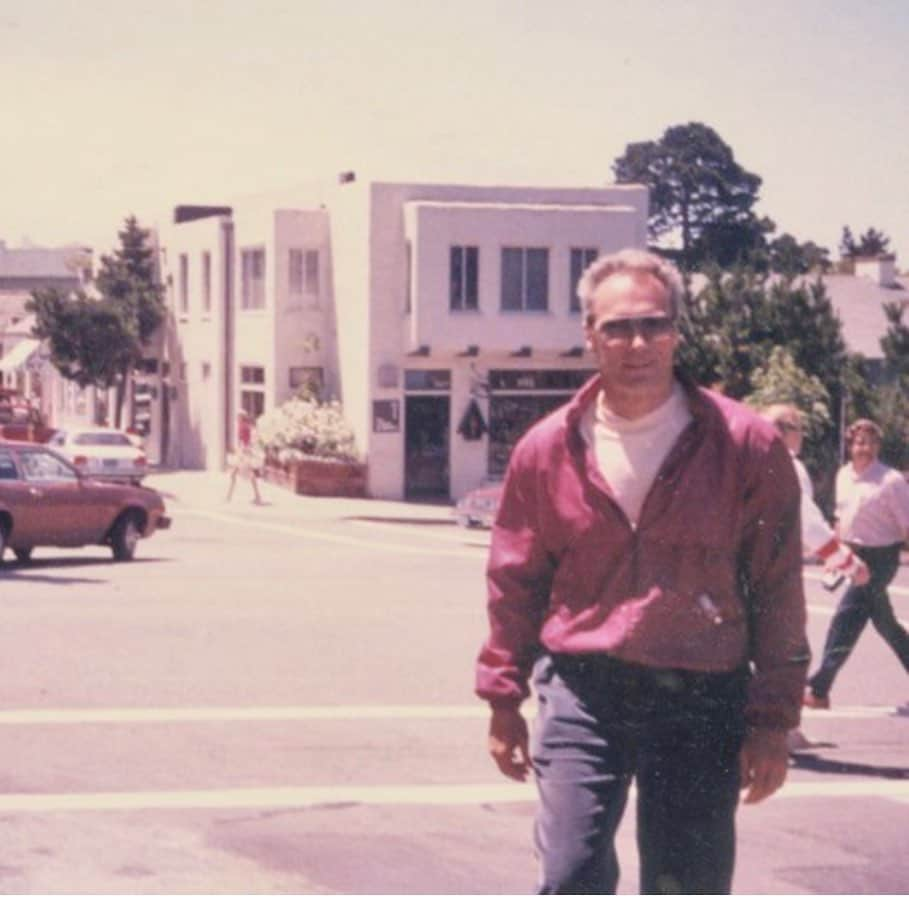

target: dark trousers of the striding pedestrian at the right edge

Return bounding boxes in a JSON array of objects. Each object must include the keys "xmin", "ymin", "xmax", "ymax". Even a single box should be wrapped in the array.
[{"xmin": 808, "ymin": 543, "xmax": 909, "ymax": 697}]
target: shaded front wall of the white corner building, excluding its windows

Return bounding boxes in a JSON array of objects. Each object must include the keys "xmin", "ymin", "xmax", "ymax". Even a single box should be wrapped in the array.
[{"xmin": 358, "ymin": 184, "xmax": 647, "ymax": 499}]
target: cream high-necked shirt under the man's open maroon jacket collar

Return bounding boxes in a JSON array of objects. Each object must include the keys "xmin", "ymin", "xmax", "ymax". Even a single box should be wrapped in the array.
[{"xmin": 580, "ymin": 382, "xmax": 691, "ymax": 526}]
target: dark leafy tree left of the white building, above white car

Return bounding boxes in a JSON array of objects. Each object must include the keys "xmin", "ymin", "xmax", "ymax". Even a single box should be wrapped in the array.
[{"xmin": 26, "ymin": 216, "xmax": 165, "ymax": 424}]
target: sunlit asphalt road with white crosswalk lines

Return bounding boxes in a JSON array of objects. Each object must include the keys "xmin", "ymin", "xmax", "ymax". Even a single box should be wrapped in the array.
[{"xmin": 0, "ymin": 476, "xmax": 909, "ymax": 894}]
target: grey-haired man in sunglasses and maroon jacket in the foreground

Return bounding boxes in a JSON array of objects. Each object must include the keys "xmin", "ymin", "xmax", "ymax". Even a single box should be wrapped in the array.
[{"xmin": 477, "ymin": 250, "xmax": 809, "ymax": 893}]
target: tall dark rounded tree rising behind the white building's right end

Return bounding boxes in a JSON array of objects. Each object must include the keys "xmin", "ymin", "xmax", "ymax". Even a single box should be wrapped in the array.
[{"xmin": 613, "ymin": 123, "xmax": 763, "ymax": 268}]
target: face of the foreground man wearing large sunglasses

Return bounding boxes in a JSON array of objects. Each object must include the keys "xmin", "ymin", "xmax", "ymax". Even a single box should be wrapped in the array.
[{"xmin": 585, "ymin": 272, "xmax": 679, "ymax": 418}]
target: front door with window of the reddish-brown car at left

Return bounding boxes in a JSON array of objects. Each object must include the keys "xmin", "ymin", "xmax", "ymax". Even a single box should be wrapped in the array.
[{"xmin": 19, "ymin": 448, "xmax": 105, "ymax": 546}]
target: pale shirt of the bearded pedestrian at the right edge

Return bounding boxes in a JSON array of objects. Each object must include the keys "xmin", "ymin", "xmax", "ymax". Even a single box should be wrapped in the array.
[{"xmin": 836, "ymin": 460, "xmax": 909, "ymax": 546}]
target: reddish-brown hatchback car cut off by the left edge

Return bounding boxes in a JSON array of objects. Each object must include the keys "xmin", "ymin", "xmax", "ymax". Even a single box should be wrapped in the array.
[{"xmin": 0, "ymin": 442, "xmax": 171, "ymax": 563}]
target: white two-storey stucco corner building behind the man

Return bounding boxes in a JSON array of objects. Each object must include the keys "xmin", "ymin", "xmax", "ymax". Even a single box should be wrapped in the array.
[{"xmin": 160, "ymin": 174, "xmax": 647, "ymax": 499}]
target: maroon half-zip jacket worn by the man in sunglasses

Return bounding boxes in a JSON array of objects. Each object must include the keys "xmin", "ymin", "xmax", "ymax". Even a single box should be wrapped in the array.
[{"xmin": 477, "ymin": 378, "xmax": 810, "ymax": 729}]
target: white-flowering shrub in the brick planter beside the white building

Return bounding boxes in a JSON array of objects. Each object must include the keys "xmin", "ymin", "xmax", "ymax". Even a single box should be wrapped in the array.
[{"xmin": 256, "ymin": 395, "xmax": 360, "ymax": 465}]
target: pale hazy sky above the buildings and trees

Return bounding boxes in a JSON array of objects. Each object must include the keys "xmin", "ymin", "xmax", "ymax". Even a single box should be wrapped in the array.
[{"xmin": 0, "ymin": 0, "xmax": 909, "ymax": 260}]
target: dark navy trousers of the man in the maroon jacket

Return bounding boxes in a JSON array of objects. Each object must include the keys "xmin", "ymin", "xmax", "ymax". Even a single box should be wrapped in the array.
[{"xmin": 531, "ymin": 654, "xmax": 747, "ymax": 894}]
